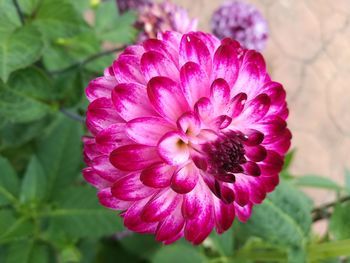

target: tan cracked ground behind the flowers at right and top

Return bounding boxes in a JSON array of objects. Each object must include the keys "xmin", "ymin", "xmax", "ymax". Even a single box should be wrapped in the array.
[{"xmin": 173, "ymin": 0, "xmax": 350, "ymax": 206}]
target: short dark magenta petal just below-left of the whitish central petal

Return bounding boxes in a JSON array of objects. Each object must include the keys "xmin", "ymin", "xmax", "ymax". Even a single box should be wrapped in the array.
[{"xmin": 140, "ymin": 163, "xmax": 175, "ymax": 188}]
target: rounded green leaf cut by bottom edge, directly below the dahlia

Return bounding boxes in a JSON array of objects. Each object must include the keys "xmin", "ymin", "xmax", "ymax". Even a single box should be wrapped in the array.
[{"xmin": 152, "ymin": 244, "xmax": 207, "ymax": 263}]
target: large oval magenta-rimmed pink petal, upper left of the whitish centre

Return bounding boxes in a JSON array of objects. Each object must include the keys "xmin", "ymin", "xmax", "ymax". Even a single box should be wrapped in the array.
[{"xmin": 147, "ymin": 77, "xmax": 189, "ymax": 122}]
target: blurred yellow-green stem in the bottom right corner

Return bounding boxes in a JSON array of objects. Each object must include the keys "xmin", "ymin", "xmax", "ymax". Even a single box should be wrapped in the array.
[{"xmin": 308, "ymin": 239, "xmax": 350, "ymax": 261}]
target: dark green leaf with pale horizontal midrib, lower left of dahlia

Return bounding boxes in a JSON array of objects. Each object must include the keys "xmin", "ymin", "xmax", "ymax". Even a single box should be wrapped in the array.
[{"xmin": 41, "ymin": 186, "xmax": 123, "ymax": 239}]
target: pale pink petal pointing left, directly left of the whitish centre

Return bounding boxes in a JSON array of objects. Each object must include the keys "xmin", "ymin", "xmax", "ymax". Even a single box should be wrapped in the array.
[{"xmin": 126, "ymin": 117, "xmax": 173, "ymax": 146}]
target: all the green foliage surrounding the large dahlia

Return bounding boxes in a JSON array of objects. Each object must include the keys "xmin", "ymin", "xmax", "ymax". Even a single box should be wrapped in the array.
[{"xmin": 0, "ymin": 0, "xmax": 350, "ymax": 263}]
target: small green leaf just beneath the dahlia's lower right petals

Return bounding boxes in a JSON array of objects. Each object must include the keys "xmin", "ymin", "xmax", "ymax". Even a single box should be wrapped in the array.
[{"xmin": 209, "ymin": 227, "xmax": 234, "ymax": 256}]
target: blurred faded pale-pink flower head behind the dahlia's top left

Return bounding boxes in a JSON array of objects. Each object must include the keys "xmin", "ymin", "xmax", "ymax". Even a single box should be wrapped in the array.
[{"xmin": 135, "ymin": 0, "xmax": 197, "ymax": 41}]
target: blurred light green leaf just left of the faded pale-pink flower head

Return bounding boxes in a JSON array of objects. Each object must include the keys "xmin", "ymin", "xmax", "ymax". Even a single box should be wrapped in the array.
[{"xmin": 95, "ymin": 1, "xmax": 137, "ymax": 44}]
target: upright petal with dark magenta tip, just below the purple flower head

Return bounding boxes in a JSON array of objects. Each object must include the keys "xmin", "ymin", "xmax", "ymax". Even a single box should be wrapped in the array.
[{"xmin": 213, "ymin": 45, "xmax": 239, "ymax": 88}]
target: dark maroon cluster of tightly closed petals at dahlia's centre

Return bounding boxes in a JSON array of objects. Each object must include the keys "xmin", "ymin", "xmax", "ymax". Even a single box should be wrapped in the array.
[{"xmin": 203, "ymin": 132, "xmax": 247, "ymax": 183}]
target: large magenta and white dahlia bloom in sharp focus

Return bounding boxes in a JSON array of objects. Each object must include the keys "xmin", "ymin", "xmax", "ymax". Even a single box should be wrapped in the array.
[{"xmin": 83, "ymin": 31, "xmax": 291, "ymax": 244}]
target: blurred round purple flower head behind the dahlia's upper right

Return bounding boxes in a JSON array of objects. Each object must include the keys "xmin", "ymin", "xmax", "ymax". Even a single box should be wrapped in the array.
[{"xmin": 211, "ymin": 1, "xmax": 268, "ymax": 51}]
